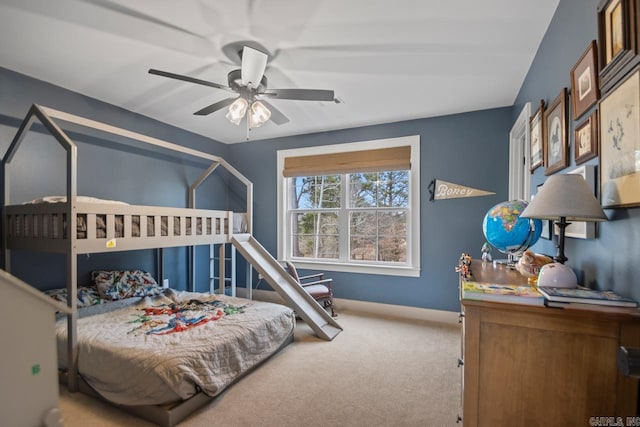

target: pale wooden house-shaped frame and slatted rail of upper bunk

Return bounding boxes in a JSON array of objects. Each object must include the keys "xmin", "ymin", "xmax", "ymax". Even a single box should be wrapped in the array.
[{"xmin": 2, "ymin": 104, "xmax": 264, "ymax": 423}]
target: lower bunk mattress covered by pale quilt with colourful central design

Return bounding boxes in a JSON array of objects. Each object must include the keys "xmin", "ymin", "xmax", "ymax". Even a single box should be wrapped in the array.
[{"xmin": 56, "ymin": 289, "xmax": 295, "ymax": 405}]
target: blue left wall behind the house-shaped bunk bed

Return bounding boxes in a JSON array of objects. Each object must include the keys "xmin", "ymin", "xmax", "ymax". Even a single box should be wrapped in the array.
[{"xmin": 0, "ymin": 68, "xmax": 228, "ymax": 290}]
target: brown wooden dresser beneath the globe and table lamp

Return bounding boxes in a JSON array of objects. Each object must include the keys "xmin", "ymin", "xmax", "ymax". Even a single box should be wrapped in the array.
[{"xmin": 459, "ymin": 260, "xmax": 640, "ymax": 427}]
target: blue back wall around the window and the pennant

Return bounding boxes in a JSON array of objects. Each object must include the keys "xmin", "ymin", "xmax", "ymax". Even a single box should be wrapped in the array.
[{"xmin": 229, "ymin": 108, "xmax": 511, "ymax": 311}]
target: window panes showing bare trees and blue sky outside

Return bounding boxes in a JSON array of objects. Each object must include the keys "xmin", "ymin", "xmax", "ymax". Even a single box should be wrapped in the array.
[{"xmin": 289, "ymin": 171, "xmax": 409, "ymax": 263}]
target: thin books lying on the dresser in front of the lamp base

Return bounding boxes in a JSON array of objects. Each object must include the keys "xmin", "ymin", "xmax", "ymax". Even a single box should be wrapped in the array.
[{"xmin": 538, "ymin": 286, "xmax": 638, "ymax": 308}]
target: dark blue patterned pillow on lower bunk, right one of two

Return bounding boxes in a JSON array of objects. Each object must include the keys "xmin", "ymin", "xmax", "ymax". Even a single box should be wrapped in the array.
[{"xmin": 91, "ymin": 270, "xmax": 163, "ymax": 301}]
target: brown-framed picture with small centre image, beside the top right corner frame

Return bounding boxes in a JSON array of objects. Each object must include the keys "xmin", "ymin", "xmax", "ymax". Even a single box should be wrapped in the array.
[{"xmin": 571, "ymin": 40, "xmax": 600, "ymax": 120}]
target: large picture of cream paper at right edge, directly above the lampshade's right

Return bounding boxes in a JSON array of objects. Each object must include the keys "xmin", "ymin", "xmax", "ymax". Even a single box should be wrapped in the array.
[{"xmin": 600, "ymin": 70, "xmax": 640, "ymax": 208}]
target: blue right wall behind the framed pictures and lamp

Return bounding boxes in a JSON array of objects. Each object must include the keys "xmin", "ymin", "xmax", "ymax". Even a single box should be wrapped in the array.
[{"xmin": 512, "ymin": 0, "xmax": 640, "ymax": 299}]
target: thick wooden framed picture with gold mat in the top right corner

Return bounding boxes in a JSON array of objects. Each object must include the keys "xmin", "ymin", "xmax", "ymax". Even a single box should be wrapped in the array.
[{"xmin": 598, "ymin": 0, "xmax": 640, "ymax": 94}]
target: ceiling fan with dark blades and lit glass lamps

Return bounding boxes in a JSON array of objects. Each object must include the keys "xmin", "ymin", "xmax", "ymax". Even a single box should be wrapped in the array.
[{"xmin": 149, "ymin": 45, "xmax": 334, "ymax": 128}]
